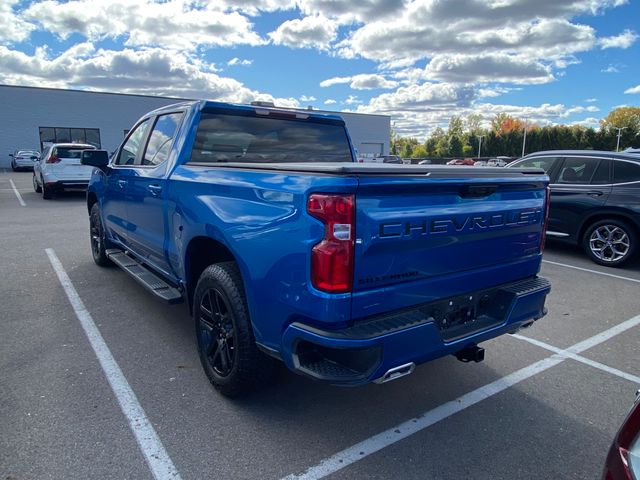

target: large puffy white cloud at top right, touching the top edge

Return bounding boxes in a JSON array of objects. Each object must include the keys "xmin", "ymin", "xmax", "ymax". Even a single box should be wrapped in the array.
[{"xmin": 339, "ymin": 0, "xmax": 608, "ymax": 64}]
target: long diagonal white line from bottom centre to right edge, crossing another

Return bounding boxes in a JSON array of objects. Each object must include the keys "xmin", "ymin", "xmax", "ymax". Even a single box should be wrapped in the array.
[{"xmin": 285, "ymin": 315, "xmax": 640, "ymax": 480}]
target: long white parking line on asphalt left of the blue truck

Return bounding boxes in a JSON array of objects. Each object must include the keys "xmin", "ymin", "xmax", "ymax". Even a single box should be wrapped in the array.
[{"xmin": 45, "ymin": 248, "xmax": 180, "ymax": 480}]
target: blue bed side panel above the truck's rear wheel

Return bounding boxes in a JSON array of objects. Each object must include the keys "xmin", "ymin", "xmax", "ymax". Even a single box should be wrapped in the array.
[{"xmin": 168, "ymin": 165, "xmax": 357, "ymax": 349}]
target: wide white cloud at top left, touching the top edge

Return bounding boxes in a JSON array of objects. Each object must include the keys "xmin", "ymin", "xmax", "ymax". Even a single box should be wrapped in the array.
[{"xmin": 23, "ymin": 0, "xmax": 265, "ymax": 50}]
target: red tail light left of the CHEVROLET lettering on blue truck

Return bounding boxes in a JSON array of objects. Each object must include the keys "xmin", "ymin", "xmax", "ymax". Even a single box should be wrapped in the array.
[{"xmin": 307, "ymin": 193, "xmax": 355, "ymax": 293}]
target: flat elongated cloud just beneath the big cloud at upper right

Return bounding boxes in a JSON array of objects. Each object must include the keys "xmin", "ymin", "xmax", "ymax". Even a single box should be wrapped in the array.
[{"xmin": 425, "ymin": 54, "xmax": 554, "ymax": 84}]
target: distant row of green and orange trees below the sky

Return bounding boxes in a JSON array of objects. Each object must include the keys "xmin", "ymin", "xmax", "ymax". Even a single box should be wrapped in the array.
[{"xmin": 391, "ymin": 107, "xmax": 640, "ymax": 158}]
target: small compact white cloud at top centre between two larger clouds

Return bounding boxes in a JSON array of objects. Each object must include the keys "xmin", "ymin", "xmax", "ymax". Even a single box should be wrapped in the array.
[{"xmin": 269, "ymin": 16, "xmax": 338, "ymax": 50}]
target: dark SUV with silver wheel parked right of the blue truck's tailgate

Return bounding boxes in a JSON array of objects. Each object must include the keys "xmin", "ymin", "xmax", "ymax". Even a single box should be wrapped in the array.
[{"xmin": 509, "ymin": 150, "xmax": 640, "ymax": 267}]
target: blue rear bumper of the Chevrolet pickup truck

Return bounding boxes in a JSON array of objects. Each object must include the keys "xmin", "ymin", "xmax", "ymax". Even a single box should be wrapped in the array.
[{"xmin": 282, "ymin": 277, "xmax": 551, "ymax": 385}]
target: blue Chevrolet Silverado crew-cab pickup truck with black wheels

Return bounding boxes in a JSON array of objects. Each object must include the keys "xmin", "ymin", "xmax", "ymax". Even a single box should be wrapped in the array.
[{"xmin": 82, "ymin": 101, "xmax": 550, "ymax": 396}]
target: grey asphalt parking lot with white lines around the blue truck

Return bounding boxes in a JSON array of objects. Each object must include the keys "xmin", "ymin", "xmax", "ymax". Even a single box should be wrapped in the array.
[{"xmin": 0, "ymin": 171, "xmax": 640, "ymax": 480}]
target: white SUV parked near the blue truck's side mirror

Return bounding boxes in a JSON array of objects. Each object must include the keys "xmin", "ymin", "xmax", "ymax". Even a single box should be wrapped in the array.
[{"xmin": 33, "ymin": 143, "xmax": 96, "ymax": 200}]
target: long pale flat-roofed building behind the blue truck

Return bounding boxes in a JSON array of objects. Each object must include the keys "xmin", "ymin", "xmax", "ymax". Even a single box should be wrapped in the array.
[{"xmin": 0, "ymin": 85, "xmax": 391, "ymax": 168}]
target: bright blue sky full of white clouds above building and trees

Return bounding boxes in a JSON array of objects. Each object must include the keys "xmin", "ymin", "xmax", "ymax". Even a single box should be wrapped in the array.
[{"xmin": 0, "ymin": 0, "xmax": 640, "ymax": 138}]
